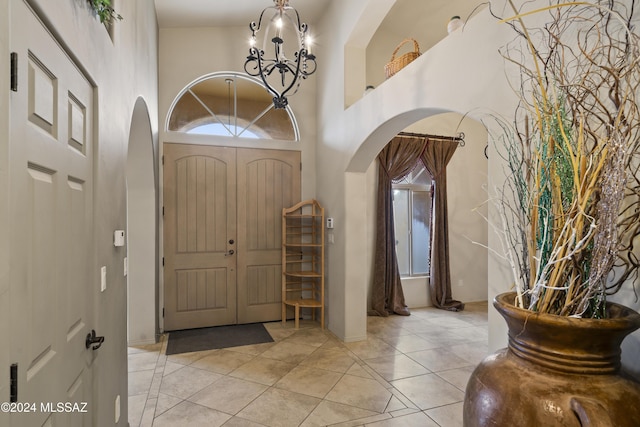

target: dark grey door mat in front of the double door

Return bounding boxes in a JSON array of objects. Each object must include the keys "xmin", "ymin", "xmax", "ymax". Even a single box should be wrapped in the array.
[{"xmin": 166, "ymin": 323, "xmax": 273, "ymax": 355}]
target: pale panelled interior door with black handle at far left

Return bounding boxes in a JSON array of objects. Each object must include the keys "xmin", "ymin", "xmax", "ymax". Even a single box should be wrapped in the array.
[{"xmin": 8, "ymin": 0, "xmax": 99, "ymax": 427}]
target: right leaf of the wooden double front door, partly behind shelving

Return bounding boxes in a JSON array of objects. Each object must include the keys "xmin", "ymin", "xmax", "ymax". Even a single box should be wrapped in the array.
[{"xmin": 238, "ymin": 149, "xmax": 301, "ymax": 323}]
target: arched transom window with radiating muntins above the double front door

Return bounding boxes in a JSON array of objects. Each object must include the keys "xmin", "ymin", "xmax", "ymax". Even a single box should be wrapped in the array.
[{"xmin": 167, "ymin": 73, "xmax": 299, "ymax": 141}]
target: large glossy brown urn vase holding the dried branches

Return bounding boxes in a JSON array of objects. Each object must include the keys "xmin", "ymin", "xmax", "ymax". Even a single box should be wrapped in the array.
[{"xmin": 464, "ymin": 292, "xmax": 640, "ymax": 427}]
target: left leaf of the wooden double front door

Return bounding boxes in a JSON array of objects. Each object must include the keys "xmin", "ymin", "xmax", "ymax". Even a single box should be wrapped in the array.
[{"xmin": 164, "ymin": 144, "xmax": 237, "ymax": 330}]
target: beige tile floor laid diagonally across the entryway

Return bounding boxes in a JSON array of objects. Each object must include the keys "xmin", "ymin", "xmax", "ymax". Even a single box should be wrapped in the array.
[{"xmin": 129, "ymin": 302, "xmax": 487, "ymax": 427}]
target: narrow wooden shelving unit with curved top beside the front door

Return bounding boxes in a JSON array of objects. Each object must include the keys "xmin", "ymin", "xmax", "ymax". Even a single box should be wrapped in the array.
[{"xmin": 282, "ymin": 200, "xmax": 324, "ymax": 329}]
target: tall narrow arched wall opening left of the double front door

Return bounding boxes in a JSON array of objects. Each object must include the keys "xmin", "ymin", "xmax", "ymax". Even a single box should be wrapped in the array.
[{"xmin": 125, "ymin": 98, "xmax": 159, "ymax": 345}]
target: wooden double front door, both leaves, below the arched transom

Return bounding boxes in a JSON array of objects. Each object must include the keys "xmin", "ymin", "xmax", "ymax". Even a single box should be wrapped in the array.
[{"xmin": 164, "ymin": 143, "xmax": 301, "ymax": 331}]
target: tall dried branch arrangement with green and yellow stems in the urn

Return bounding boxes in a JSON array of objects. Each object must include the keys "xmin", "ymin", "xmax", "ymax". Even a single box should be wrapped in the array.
[{"xmin": 493, "ymin": 0, "xmax": 640, "ymax": 317}]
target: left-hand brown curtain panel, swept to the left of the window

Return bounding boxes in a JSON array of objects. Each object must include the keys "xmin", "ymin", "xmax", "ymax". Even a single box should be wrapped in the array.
[{"xmin": 369, "ymin": 137, "xmax": 425, "ymax": 316}]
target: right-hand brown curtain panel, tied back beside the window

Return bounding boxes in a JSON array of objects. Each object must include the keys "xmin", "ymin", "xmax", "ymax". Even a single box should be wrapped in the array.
[{"xmin": 420, "ymin": 139, "xmax": 464, "ymax": 311}]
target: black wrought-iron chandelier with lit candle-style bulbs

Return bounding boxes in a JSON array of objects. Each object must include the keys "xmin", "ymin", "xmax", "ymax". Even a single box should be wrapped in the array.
[{"xmin": 244, "ymin": 0, "xmax": 316, "ymax": 108}]
